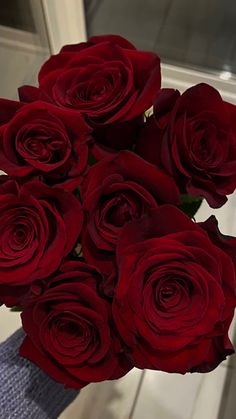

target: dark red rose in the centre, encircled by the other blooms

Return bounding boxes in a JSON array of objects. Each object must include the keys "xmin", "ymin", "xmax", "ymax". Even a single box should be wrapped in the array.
[{"xmin": 81, "ymin": 151, "xmax": 179, "ymax": 291}]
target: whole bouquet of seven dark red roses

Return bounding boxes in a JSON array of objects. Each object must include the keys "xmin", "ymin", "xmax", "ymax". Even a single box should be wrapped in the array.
[{"xmin": 0, "ymin": 35, "xmax": 236, "ymax": 388}]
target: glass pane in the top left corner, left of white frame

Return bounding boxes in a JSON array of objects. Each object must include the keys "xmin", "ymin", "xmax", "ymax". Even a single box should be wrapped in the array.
[{"xmin": 0, "ymin": 0, "xmax": 50, "ymax": 99}]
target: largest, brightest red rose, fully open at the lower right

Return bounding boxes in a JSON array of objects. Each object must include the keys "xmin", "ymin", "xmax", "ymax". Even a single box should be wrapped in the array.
[{"xmin": 113, "ymin": 205, "xmax": 236, "ymax": 374}]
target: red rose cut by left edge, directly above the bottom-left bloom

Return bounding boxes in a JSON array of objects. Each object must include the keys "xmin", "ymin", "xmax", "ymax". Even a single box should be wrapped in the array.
[{"xmin": 0, "ymin": 176, "xmax": 83, "ymax": 305}]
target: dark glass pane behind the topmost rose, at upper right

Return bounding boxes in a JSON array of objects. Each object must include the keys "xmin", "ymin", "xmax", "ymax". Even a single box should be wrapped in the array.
[{"xmin": 84, "ymin": 0, "xmax": 236, "ymax": 78}]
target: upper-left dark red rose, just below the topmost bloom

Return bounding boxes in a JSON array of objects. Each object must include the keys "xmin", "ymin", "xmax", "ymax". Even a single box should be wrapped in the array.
[{"xmin": 0, "ymin": 99, "xmax": 91, "ymax": 190}]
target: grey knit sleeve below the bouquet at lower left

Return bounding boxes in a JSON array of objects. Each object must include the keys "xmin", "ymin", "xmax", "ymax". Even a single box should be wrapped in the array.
[{"xmin": 0, "ymin": 329, "xmax": 78, "ymax": 419}]
